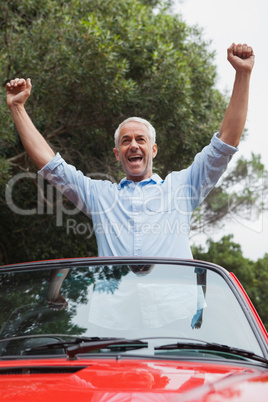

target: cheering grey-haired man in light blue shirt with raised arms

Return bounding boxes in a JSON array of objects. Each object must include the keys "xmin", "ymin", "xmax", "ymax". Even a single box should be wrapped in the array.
[{"xmin": 7, "ymin": 44, "xmax": 254, "ymax": 258}]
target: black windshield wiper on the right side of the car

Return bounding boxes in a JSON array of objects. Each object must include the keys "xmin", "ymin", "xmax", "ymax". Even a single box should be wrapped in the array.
[{"xmin": 155, "ymin": 342, "xmax": 268, "ymax": 364}]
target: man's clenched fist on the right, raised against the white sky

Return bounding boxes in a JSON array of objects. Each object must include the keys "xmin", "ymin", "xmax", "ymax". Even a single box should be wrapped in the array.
[{"xmin": 227, "ymin": 43, "xmax": 255, "ymax": 73}]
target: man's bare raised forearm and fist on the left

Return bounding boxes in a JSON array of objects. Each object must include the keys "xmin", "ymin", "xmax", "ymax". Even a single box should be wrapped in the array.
[{"xmin": 6, "ymin": 78, "xmax": 55, "ymax": 169}]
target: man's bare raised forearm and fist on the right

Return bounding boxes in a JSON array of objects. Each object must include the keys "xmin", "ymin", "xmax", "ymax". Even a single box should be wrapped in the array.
[{"xmin": 219, "ymin": 43, "xmax": 254, "ymax": 147}]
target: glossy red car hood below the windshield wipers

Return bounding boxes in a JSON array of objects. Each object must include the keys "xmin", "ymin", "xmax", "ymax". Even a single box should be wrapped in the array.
[{"xmin": 0, "ymin": 358, "xmax": 268, "ymax": 402}]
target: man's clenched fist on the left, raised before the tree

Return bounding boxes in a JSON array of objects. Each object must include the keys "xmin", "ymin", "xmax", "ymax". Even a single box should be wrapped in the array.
[{"xmin": 6, "ymin": 78, "xmax": 32, "ymax": 108}]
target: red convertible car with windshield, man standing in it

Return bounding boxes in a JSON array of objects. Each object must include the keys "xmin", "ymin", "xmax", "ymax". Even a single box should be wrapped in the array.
[{"xmin": 0, "ymin": 257, "xmax": 268, "ymax": 402}]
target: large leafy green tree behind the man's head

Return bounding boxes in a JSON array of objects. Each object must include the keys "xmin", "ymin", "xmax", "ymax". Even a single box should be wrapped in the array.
[{"xmin": 0, "ymin": 0, "xmax": 226, "ymax": 263}]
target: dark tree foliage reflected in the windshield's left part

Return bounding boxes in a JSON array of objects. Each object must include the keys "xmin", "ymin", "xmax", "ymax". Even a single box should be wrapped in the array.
[{"xmin": 0, "ymin": 265, "xmax": 129, "ymax": 338}]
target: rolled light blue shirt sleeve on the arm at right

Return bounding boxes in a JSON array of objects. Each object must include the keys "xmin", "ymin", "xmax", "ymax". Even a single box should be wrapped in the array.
[{"xmin": 189, "ymin": 133, "xmax": 238, "ymax": 209}]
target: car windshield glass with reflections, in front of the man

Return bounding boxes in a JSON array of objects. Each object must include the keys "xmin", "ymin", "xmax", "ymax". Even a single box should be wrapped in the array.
[{"xmin": 0, "ymin": 260, "xmax": 263, "ymax": 356}]
